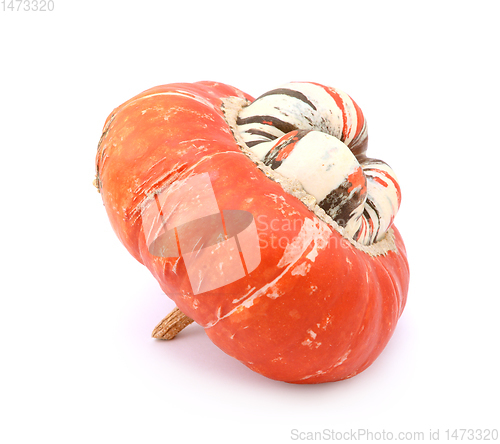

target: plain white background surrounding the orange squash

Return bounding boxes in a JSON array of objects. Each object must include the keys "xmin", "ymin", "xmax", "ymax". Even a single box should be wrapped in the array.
[{"xmin": 0, "ymin": 0, "xmax": 500, "ymax": 444}]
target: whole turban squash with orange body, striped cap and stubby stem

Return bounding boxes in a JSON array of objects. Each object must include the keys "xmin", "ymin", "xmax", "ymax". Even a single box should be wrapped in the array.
[{"xmin": 95, "ymin": 82, "xmax": 409, "ymax": 383}]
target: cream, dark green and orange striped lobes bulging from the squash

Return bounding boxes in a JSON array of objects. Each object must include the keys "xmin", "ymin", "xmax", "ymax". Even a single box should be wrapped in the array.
[{"xmin": 237, "ymin": 82, "xmax": 401, "ymax": 245}]
